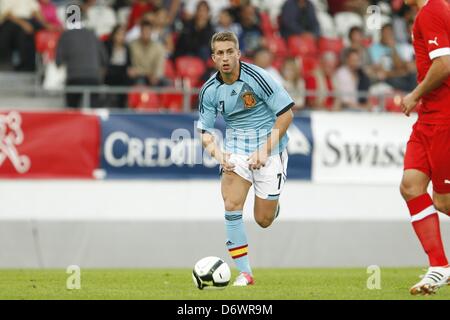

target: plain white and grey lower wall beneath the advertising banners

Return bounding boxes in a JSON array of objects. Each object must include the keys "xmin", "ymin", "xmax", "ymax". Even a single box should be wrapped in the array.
[{"xmin": 0, "ymin": 180, "xmax": 450, "ymax": 268}]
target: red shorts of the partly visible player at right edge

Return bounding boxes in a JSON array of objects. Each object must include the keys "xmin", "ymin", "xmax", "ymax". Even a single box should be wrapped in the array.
[{"xmin": 404, "ymin": 123, "xmax": 450, "ymax": 194}]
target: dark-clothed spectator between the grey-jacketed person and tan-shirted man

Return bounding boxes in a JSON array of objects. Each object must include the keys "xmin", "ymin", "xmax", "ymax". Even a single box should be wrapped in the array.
[{"xmin": 105, "ymin": 26, "xmax": 133, "ymax": 108}]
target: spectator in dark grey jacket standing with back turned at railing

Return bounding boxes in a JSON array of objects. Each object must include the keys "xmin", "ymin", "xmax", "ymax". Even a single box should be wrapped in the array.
[{"xmin": 56, "ymin": 19, "xmax": 107, "ymax": 108}]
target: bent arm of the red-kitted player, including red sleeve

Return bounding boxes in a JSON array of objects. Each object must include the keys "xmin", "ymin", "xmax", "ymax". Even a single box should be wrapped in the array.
[{"xmin": 402, "ymin": 13, "xmax": 450, "ymax": 116}]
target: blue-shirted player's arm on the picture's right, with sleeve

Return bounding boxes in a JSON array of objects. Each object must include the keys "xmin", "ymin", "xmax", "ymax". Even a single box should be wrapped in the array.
[{"xmin": 248, "ymin": 69, "xmax": 294, "ymax": 169}]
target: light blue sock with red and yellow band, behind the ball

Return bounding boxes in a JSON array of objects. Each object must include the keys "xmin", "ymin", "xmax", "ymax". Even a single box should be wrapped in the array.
[{"xmin": 225, "ymin": 210, "xmax": 252, "ymax": 274}]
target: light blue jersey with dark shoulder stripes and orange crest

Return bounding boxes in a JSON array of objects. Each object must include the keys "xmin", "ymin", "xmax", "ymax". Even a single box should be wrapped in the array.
[{"xmin": 197, "ymin": 62, "xmax": 294, "ymax": 155}]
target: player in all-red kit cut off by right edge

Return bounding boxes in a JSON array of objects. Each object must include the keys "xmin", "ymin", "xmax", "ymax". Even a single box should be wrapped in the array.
[{"xmin": 400, "ymin": 0, "xmax": 450, "ymax": 295}]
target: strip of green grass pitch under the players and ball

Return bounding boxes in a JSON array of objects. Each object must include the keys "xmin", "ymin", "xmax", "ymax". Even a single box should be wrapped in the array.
[{"xmin": 0, "ymin": 268, "xmax": 450, "ymax": 300}]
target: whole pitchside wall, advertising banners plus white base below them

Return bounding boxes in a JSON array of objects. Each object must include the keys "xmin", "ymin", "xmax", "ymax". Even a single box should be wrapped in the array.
[{"xmin": 0, "ymin": 110, "xmax": 450, "ymax": 268}]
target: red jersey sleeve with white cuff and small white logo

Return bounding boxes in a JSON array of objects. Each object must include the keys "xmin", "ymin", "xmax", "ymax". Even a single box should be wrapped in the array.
[{"xmin": 419, "ymin": 6, "xmax": 450, "ymax": 60}]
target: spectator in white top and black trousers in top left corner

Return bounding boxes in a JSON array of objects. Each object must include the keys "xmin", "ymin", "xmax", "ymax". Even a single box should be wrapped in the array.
[{"xmin": 0, "ymin": 0, "xmax": 55, "ymax": 71}]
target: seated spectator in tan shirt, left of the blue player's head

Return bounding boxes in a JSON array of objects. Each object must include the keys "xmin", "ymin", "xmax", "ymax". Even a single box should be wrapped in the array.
[{"xmin": 130, "ymin": 21, "xmax": 169, "ymax": 86}]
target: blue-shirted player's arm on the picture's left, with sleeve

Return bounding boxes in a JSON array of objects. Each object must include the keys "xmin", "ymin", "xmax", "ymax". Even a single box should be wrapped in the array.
[{"xmin": 197, "ymin": 85, "xmax": 234, "ymax": 172}]
